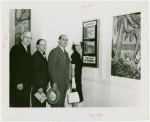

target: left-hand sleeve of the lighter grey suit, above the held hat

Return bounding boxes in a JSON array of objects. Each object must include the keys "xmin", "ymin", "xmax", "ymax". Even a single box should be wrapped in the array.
[{"xmin": 48, "ymin": 50, "xmax": 57, "ymax": 85}]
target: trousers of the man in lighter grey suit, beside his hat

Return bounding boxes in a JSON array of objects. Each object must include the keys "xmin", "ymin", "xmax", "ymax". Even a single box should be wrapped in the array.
[{"xmin": 51, "ymin": 85, "xmax": 68, "ymax": 107}]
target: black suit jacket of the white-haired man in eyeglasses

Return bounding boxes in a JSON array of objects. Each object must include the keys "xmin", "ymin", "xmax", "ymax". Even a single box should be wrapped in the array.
[{"xmin": 10, "ymin": 43, "xmax": 32, "ymax": 90}]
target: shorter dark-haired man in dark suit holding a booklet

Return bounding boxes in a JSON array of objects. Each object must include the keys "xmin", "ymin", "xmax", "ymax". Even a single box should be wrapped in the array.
[{"xmin": 32, "ymin": 39, "xmax": 49, "ymax": 107}]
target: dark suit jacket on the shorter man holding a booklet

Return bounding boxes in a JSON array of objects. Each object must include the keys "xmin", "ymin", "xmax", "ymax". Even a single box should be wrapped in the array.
[{"xmin": 32, "ymin": 50, "xmax": 49, "ymax": 92}]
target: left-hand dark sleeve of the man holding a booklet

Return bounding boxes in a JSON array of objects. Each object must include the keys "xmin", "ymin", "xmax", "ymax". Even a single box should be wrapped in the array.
[{"xmin": 32, "ymin": 55, "xmax": 43, "ymax": 89}]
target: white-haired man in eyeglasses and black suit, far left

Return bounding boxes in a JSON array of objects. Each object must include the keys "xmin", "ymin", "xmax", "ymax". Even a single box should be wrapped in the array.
[{"xmin": 10, "ymin": 31, "xmax": 32, "ymax": 107}]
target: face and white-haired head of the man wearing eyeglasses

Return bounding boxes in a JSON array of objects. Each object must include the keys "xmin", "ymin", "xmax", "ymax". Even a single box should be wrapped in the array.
[{"xmin": 21, "ymin": 32, "xmax": 32, "ymax": 46}]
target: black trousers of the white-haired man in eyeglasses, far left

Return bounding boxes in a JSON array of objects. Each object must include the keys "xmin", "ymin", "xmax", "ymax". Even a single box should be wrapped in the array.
[{"xmin": 10, "ymin": 89, "xmax": 30, "ymax": 107}]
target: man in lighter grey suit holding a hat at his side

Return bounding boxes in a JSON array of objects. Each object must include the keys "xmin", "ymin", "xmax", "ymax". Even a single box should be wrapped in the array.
[{"xmin": 48, "ymin": 35, "xmax": 70, "ymax": 107}]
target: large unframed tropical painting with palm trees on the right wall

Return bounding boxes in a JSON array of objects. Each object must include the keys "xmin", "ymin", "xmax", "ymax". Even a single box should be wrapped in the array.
[{"xmin": 111, "ymin": 12, "xmax": 141, "ymax": 80}]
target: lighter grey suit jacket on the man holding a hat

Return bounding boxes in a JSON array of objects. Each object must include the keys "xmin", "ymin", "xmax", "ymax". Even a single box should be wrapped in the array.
[{"xmin": 48, "ymin": 46, "xmax": 70, "ymax": 86}]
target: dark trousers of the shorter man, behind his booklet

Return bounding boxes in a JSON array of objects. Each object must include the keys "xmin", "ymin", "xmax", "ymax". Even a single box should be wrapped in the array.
[{"xmin": 31, "ymin": 90, "xmax": 46, "ymax": 107}]
